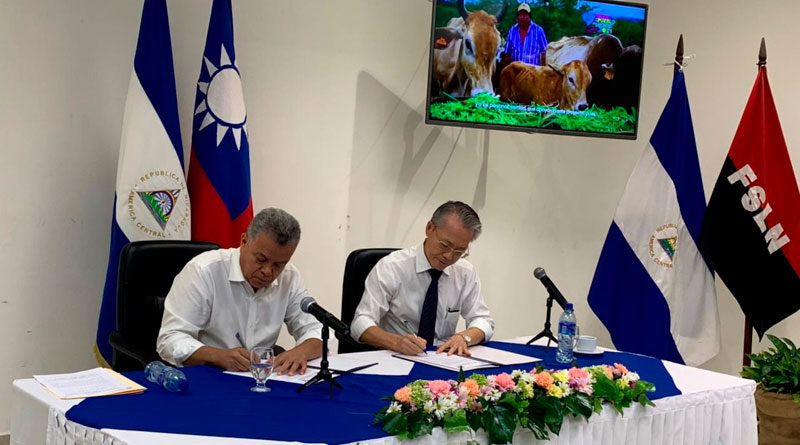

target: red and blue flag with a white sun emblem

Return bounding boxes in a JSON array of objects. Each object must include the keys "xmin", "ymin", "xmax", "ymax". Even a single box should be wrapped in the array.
[{"xmin": 188, "ymin": 0, "xmax": 253, "ymax": 247}]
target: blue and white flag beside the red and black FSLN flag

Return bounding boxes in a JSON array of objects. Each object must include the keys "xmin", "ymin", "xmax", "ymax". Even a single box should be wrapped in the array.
[{"xmin": 588, "ymin": 70, "xmax": 720, "ymax": 365}]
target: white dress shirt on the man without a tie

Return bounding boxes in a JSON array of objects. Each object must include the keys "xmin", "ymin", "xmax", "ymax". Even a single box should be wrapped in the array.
[{"xmin": 156, "ymin": 248, "xmax": 322, "ymax": 366}]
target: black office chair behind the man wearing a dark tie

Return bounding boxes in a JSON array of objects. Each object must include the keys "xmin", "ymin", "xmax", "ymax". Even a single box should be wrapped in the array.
[{"xmin": 339, "ymin": 248, "xmax": 397, "ymax": 354}]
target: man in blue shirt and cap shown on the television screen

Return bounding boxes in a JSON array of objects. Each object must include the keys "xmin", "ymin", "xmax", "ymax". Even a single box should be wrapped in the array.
[{"xmin": 501, "ymin": 3, "xmax": 547, "ymax": 66}]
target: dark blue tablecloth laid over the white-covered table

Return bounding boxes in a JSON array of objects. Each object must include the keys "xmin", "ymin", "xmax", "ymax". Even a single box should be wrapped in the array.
[{"xmin": 66, "ymin": 342, "xmax": 680, "ymax": 443}]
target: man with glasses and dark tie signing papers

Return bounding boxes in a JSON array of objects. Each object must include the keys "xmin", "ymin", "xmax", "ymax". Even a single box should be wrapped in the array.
[{"xmin": 350, "ymin": 201, "xmax": 494, "ymax": 355}]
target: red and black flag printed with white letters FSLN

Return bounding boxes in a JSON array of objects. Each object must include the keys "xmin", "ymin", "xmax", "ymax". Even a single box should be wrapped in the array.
[{"xmin": 701, "ymin": 66, "xmax": 800, "ymax": 338}]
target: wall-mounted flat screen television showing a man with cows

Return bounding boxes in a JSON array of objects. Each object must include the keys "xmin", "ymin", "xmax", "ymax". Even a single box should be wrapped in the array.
[{"xmin": 425, "ymin": 0, "xmax": 647, "ymax": 139}]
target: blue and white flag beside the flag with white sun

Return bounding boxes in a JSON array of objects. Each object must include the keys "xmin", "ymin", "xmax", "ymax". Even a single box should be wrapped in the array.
[{"xmin": 95, "ymin": 0, "xmax": 191, "ymax": 365}]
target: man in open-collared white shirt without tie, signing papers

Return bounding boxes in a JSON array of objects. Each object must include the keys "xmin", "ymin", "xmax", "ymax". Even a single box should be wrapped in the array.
[{"xmin": 156, "ymin": 208, "xmax": 322, "ymax": 375}]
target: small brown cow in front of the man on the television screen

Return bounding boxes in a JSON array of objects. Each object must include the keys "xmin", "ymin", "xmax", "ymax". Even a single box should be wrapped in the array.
[{"xmin": 498, "ymin": 60, "xmax": 592, "ymax": 110}]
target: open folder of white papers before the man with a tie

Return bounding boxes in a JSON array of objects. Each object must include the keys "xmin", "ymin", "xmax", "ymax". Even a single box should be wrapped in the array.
[{"xmin": 395, "ymin": 346, "xmax": 541, "ymax": 371}]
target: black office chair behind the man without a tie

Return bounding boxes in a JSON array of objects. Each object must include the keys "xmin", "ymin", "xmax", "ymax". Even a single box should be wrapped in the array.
[{"xmin": 109, "ymin": 241, "xmax": 219, "ymax": 371}]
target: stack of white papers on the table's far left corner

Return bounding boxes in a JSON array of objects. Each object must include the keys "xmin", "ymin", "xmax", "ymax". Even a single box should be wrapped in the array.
[{"xmin": 33, "ymin": 368, "xmax": 145, "ymax": 399}]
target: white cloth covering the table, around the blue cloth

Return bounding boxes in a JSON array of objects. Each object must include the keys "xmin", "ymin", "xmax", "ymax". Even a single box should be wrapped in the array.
[{"xmin": 11, "ymin": 337, "xmax": 757, "ymax": 445}]
